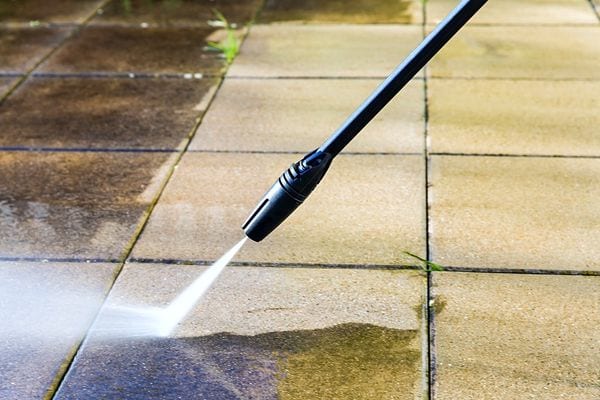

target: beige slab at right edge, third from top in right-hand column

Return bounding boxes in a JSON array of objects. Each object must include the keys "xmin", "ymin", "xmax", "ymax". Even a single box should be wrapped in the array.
[{"xmin": 428, "ymin": 79, "xmax": 600, "ymax": 156}]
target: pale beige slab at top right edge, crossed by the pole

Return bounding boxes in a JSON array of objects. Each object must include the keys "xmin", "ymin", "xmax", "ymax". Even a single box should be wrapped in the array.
[{"xmin": 427, "ymin": 0, "xmax": 598, "ymax": 25}]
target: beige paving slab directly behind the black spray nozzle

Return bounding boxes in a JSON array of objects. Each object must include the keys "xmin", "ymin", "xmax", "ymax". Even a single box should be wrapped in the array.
[{"xmin": 133, "ymin": 153, "xmax": 424, "ymax": 264}]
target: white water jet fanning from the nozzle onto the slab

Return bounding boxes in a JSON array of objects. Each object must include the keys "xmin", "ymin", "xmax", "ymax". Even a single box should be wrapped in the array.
[{"xmin": 96, "ymin": 237, "xmax": 247, "ymax": 337}]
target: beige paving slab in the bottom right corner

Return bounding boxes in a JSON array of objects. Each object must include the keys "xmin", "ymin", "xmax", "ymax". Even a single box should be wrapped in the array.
[{"xmin": 433, "ymin": 273, "xmax": 600, "ymax": 400}]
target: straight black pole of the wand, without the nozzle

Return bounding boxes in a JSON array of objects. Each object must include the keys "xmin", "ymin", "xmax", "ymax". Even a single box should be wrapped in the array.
[{"xmin": 319, "ymin": 0, "xmax": 487, "ymax": 157}]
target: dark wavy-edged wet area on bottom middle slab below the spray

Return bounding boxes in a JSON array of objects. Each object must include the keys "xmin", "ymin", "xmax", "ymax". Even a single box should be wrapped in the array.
[{"xmin": 57, "ymin": 323, "xmax": 420, "ymax": 400}]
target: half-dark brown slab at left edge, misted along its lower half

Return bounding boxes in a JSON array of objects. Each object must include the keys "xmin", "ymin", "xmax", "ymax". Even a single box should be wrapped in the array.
[{"xmin": 0, "ymin": 152, "xmax": 175, "ymax": 259}]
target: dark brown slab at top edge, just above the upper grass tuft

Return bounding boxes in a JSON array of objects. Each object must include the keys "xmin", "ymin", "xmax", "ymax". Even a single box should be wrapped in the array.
[{"xmin": 91, "ymin": 0, "xmax": 261, "ymax": 27}]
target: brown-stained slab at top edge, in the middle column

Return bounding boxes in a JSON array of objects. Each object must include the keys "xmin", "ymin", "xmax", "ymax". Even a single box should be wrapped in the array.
[{"xmin": 258, "ymin": 0, "xmax": 423, "ymax": 24}]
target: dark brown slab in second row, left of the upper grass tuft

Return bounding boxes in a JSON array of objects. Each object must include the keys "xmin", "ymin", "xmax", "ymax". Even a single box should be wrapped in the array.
[{"xmin": 39, "ymin": 26, "xmax": 225, "ymax": 75}]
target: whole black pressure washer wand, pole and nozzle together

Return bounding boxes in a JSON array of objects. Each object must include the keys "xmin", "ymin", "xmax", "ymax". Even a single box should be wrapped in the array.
[{"xmin": 242, "ymin": 0, "xmax": 487, "ymax": 242}]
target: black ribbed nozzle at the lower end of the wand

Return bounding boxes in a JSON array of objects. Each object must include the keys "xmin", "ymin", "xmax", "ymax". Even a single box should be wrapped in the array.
[{"xmin": 242, "ymin": 150, "xmax": 332, "ymax": 242}]
